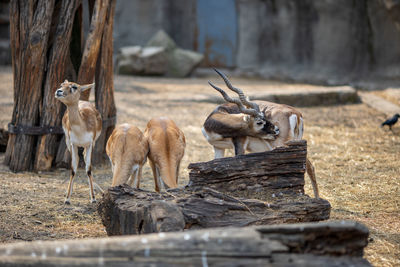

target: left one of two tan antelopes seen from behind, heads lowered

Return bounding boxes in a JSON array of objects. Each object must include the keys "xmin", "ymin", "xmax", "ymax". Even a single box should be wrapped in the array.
[{"xmin": 106, "ymin": 123, "xmax": 149, "ymax": 188}]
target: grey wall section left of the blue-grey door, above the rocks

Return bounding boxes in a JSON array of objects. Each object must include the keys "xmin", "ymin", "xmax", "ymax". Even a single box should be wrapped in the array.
[{"xmin": 114, "ymin": 0, "xmax": 196, "ymax": 51}]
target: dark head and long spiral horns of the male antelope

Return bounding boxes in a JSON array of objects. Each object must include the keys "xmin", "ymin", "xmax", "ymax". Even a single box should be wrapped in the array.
[{"xmin": 208, "ymin": 69, "xmax": 279, "ymax": 140}]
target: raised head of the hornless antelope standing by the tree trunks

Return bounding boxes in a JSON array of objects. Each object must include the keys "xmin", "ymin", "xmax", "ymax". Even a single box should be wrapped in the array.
[{"xmin": 55, "ymin": 80, "xmax": 94, "ymax": 105}]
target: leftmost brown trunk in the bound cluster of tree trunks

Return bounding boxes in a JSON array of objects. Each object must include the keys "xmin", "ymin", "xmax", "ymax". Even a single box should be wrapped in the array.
[{"xmin": 5, "ymin": 0, "xmax": 54, "ymax": 171}]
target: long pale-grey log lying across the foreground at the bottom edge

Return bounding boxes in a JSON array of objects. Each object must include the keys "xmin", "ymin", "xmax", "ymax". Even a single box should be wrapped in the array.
[{"xmin": 0, "ymin": 221, "xmax": 370, "ymax": 266}]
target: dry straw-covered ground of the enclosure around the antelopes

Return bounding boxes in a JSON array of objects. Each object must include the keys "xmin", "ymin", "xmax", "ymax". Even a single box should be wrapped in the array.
[{"xmin": 0, "ymin": 69, "xmax": 400, "ymax": 266}]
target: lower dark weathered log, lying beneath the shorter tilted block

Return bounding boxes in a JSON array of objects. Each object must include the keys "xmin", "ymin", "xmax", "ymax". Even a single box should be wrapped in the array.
[{"xmin": 98, "ymin": 185, "xmax": 330, "ymax": 235}]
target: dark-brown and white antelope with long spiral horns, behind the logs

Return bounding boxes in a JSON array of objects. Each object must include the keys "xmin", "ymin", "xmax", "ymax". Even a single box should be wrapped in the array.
[{"xmin": 202, "ymin": 70, "xmax": 319, "ymax": 198}]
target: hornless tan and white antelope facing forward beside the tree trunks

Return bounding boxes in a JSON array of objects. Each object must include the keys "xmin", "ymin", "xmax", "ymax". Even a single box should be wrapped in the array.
[{"xmin": 55, "ymin": 80, "xmax": 102, "ymax": 204}]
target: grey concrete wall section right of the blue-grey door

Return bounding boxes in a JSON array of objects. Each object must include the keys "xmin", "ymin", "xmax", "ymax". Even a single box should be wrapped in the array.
[{"xmin": 237, "ymin": 0, "xmax": 400, "ymax": 83}]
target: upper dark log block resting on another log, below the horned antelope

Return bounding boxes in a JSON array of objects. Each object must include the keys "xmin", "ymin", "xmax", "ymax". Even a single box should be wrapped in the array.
[{"xmin": 188, "ymin": 140, "xmax": 307, "ymax": 199}]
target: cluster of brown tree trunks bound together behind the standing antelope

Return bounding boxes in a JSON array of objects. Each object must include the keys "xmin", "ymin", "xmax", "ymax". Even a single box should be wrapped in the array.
[{"xmin": 5, "ymin": 0, "xmax": 116, "ymax": 171}]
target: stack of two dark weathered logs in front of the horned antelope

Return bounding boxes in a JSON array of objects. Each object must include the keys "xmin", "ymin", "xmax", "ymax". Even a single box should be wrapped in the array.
[{"xmin": 98, "ymin": 141, "xmax": 330, "ymax": 235}]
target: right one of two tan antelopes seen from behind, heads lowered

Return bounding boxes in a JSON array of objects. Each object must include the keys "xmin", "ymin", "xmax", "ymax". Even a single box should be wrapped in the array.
[{"xmin": 144, "ymin": 117, "xmax": 186, "ymax": 192}]
